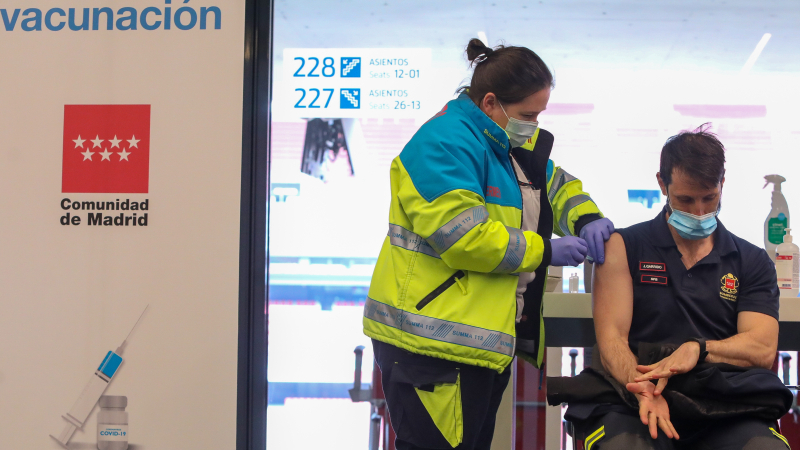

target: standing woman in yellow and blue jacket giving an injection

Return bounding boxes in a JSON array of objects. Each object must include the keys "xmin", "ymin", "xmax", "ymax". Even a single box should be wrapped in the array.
[{"xmin": 363, "ymin": 39, "xmax": 614, "ymax": 450}]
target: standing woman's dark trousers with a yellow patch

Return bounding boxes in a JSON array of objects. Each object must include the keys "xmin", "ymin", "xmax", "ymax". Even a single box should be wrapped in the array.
[{"xmin": 372, "ymin": 339, "xmax": 511, "ymax": 450}]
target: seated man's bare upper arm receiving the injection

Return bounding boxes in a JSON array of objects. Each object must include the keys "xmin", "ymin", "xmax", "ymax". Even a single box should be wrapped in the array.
[{"xmin": 592, "ymin": 233, "xmax": 633, "ymax": 347}]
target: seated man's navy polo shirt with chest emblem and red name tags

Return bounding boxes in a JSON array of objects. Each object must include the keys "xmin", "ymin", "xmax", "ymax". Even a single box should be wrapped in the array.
[{"xmin": 617, "ymin": 210, "xmax": 780, "ymax": 354}]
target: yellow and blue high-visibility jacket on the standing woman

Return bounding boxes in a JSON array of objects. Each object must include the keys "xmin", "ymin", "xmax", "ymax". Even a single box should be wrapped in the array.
[{"xmin": 363, "ymin": 94, "xmax": 600, "ymax": 372}]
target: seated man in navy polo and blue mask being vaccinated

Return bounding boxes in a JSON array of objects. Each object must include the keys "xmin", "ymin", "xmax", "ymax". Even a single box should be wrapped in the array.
[{"xmin": 567, "ymin": 129, "xmax": 791, "ymax": 450}]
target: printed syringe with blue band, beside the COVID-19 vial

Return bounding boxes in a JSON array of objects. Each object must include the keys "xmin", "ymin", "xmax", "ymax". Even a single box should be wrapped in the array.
[{"xmin": 50, "ymin": 305, "xmax": 150, "ymax": 448}]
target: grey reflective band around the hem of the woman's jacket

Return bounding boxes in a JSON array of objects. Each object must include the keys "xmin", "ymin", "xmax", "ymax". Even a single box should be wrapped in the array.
[{"xmin": 364, "ymin": 297, "xmax": 514, "ymax": 356}]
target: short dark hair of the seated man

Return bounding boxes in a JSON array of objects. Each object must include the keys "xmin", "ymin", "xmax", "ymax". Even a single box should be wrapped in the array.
[{"xmin": 660, "ymin": 123, "xmax": 725, "ymax": 188}]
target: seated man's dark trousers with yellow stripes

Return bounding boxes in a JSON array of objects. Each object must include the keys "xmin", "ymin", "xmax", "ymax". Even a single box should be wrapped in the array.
[{"xmin": 573, "ymin": 412, "xmax": 789, "ymax": 450}]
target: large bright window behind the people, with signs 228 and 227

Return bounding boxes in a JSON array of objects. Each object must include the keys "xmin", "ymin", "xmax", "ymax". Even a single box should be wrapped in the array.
[{"xmin": 268, "ymin": 1, "xmax": 800, "ymax": 449}]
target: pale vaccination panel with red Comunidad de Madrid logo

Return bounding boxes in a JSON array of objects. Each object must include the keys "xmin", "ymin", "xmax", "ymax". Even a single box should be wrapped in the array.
[{"xmin": 0, "ymin": 0, "xmax": 245, "ymax": 450}]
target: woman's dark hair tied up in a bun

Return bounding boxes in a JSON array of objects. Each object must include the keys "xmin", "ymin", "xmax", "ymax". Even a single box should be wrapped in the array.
[{"xmin": 459, "ymin": 39, "xmax": 553, "ymax": 105}]
